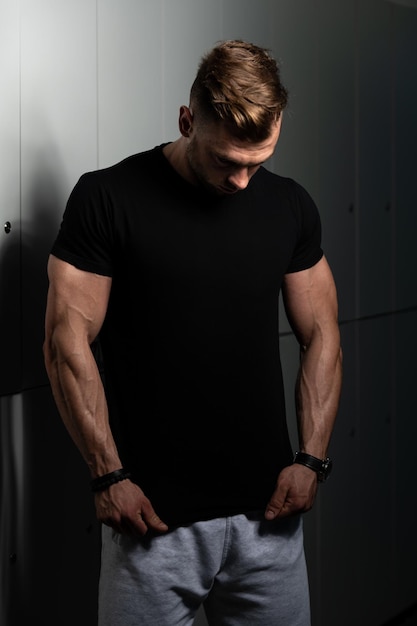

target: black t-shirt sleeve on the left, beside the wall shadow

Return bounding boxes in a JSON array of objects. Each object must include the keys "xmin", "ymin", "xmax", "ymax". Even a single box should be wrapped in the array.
[{"xmin": 51, "ymin": 172, "xmax": 113, "ymax": 276}]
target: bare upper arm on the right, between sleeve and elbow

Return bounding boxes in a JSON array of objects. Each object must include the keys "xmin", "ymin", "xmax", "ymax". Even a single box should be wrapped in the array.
[{"xmin": 282, "ymin": 257, "xmax": 338, "ymax": 346}]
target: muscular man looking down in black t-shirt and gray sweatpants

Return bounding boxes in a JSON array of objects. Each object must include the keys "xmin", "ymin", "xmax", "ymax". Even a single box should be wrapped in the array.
[{"xmin": 44, "ymin": 41, "xmax": 341, "ymax": 626}]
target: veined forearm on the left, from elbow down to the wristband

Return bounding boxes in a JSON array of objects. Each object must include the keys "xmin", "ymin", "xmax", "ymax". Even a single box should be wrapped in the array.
[{"xmin": 45, "ymin": 336, "xmax": 121, "ymax": 478}]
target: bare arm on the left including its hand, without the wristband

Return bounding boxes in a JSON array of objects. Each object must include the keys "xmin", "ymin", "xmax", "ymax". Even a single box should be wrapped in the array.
[{"xmin": 44, "ymin": 256, "xmax": 166, "ymax": 534}]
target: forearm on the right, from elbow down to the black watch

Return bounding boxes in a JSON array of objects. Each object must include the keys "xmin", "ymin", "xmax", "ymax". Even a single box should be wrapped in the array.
[{"xmin": 296, "ymin": 327, "xmax": 342, "ymax": 459}]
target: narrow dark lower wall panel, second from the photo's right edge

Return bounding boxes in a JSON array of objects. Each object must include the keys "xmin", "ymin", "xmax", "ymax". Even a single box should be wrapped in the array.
[{"xmin": 354, "ymin": 316, "xmax": 395, "ymax": 624}]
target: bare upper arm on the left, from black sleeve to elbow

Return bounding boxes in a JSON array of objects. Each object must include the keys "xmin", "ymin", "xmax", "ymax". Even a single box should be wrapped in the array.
[{"xmin": 45, "ymin": 255, "xmax": 111, "ymax": 343}]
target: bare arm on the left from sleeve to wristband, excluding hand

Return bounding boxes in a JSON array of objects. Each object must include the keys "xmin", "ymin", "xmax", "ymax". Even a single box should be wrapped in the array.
[{"xmin": 44, "ymin": 256, "xmax": 120, "ymax": 478}]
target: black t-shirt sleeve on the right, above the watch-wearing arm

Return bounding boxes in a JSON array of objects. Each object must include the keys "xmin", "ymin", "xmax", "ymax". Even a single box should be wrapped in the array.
[{"xmin": 287, "ymin": 178, "xmax": 323, "ymax": 273}]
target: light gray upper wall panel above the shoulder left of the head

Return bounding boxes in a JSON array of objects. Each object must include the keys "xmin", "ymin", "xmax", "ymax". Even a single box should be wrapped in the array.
[{"xmin": 97, "ymin": 0, "xmax": 165, "ymax": 167}]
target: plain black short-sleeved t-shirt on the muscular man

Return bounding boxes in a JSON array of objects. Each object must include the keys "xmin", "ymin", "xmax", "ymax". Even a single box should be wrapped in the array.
[{"xmin": 52, "ymin": 146, "xmax": 322, "ymax": 525}]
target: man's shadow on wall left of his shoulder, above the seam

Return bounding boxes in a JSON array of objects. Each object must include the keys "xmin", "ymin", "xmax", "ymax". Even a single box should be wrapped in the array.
[{"xmin": 0, "ymin": 141, "xmax": 67, "ymax": 396}]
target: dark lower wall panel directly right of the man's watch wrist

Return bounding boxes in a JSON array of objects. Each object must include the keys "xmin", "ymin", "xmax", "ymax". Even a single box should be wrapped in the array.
[{"xmin": 316, "ymin": 324, "xmax": 360, "ymax": 626}]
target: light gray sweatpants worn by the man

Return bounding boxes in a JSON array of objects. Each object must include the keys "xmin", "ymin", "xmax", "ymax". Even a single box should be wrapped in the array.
[{"xmin": 99, "ymin": 512, "xmax": 310, "ymax": 626}]
